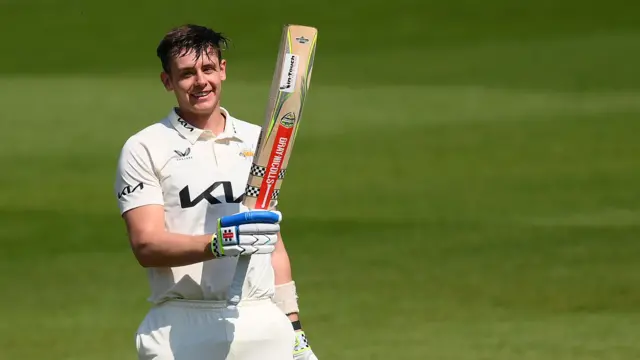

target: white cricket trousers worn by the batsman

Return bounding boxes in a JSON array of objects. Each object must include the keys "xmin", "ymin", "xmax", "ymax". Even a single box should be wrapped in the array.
[{"xmin": 136, "ymin": 300, "xmax": 295, "ymax": 360}]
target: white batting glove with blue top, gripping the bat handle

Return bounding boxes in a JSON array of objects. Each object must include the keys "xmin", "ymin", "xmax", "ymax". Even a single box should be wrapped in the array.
[{"xmin": 211, "ymin": 210, "xmax": 282, "ymax": 258}]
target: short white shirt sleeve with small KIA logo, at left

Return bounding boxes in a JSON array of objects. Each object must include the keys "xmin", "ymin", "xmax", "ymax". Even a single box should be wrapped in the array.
[{"xmin": 114, "ymin": 138, "xmax": 164, "ymax": 214}]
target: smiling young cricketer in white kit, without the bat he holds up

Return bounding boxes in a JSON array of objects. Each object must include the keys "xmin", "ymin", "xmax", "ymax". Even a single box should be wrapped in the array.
[{"xmin": 115, "ymin": 25, "xmax": 316, "ymax": 360}]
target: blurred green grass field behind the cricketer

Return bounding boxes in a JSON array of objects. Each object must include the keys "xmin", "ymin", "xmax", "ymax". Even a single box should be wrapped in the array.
[{"xmin": 0, "ymin": 0, "xmax": 640, "ymax": 360}]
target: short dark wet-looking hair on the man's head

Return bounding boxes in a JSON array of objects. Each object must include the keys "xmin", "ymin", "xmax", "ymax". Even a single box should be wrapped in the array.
[{"xmin": 156, "ymin": 24, "xmax": 229, "ymax": 73}]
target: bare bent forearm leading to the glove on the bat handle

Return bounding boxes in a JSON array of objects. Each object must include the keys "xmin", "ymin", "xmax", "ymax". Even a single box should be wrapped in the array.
[{"xmin": 133, "ymin": 231, "xmax": 214, "ymax": 267}]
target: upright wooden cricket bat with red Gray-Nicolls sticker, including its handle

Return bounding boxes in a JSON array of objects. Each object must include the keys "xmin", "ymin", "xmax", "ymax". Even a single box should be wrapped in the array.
[{"xmin": 231, "ymin": 25, "xmax": 318, "ymax": 300}]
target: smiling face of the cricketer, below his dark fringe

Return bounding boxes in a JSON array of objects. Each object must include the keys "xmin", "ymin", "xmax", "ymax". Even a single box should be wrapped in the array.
[{"xmin": 161, "ymin": 48, "xmax": 227, "ymax": 115}]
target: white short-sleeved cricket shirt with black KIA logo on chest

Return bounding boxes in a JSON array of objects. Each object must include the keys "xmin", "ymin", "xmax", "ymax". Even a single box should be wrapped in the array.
[{"xmin": 115, "ymin": 109, "xmax": 274, "ymax": 303}]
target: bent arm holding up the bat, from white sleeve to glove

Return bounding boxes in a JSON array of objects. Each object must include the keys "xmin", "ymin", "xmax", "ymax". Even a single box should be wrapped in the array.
[{"xmin": 115, "ymin": 139, "xmax": 281, "ymax": 267}]
